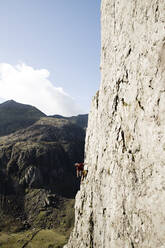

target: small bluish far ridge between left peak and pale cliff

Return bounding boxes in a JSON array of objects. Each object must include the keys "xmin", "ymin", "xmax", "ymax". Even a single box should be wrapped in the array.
[{"xmin": 51, "ymin": 114, "xmax": 88, "ymax": 129}]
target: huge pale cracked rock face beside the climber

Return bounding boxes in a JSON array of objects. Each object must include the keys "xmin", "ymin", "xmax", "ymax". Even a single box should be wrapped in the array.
[{"xmin": 67, "ymin": 0, "xmax": 165, "ymax": 248}]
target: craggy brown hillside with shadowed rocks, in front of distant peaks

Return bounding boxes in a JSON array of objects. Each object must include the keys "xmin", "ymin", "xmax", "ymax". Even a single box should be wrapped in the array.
[{"xmin": 0, "ymin": 108, "xmax": 85, "ymax": 240}]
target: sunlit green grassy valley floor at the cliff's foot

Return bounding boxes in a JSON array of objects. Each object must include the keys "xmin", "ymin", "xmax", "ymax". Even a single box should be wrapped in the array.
[{"xmin": 0, "ymin": 199, "xmax": 74, "ymax": 248}]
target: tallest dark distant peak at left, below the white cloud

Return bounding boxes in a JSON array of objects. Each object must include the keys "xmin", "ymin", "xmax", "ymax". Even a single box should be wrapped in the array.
[{"xmin": 0, "ymin": 100, "xmax": 46, "ymax": 136}]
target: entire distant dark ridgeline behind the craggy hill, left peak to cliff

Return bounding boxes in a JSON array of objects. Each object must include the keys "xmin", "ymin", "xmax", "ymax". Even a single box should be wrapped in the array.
[{"xmin": 0, "ymin": 100, "xmax": 88, "ymax": 137}]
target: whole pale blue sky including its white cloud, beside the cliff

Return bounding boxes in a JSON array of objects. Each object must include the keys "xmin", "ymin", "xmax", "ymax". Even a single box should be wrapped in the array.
[{"xmin": 0, "ymin": 0, "xmax": 100, "ymax": 115}]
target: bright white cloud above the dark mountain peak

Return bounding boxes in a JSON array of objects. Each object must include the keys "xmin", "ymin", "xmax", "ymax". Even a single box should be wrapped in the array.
[{"xmin": 0, "ymin": 63, "xmax": 82, "ymax": 116}]
